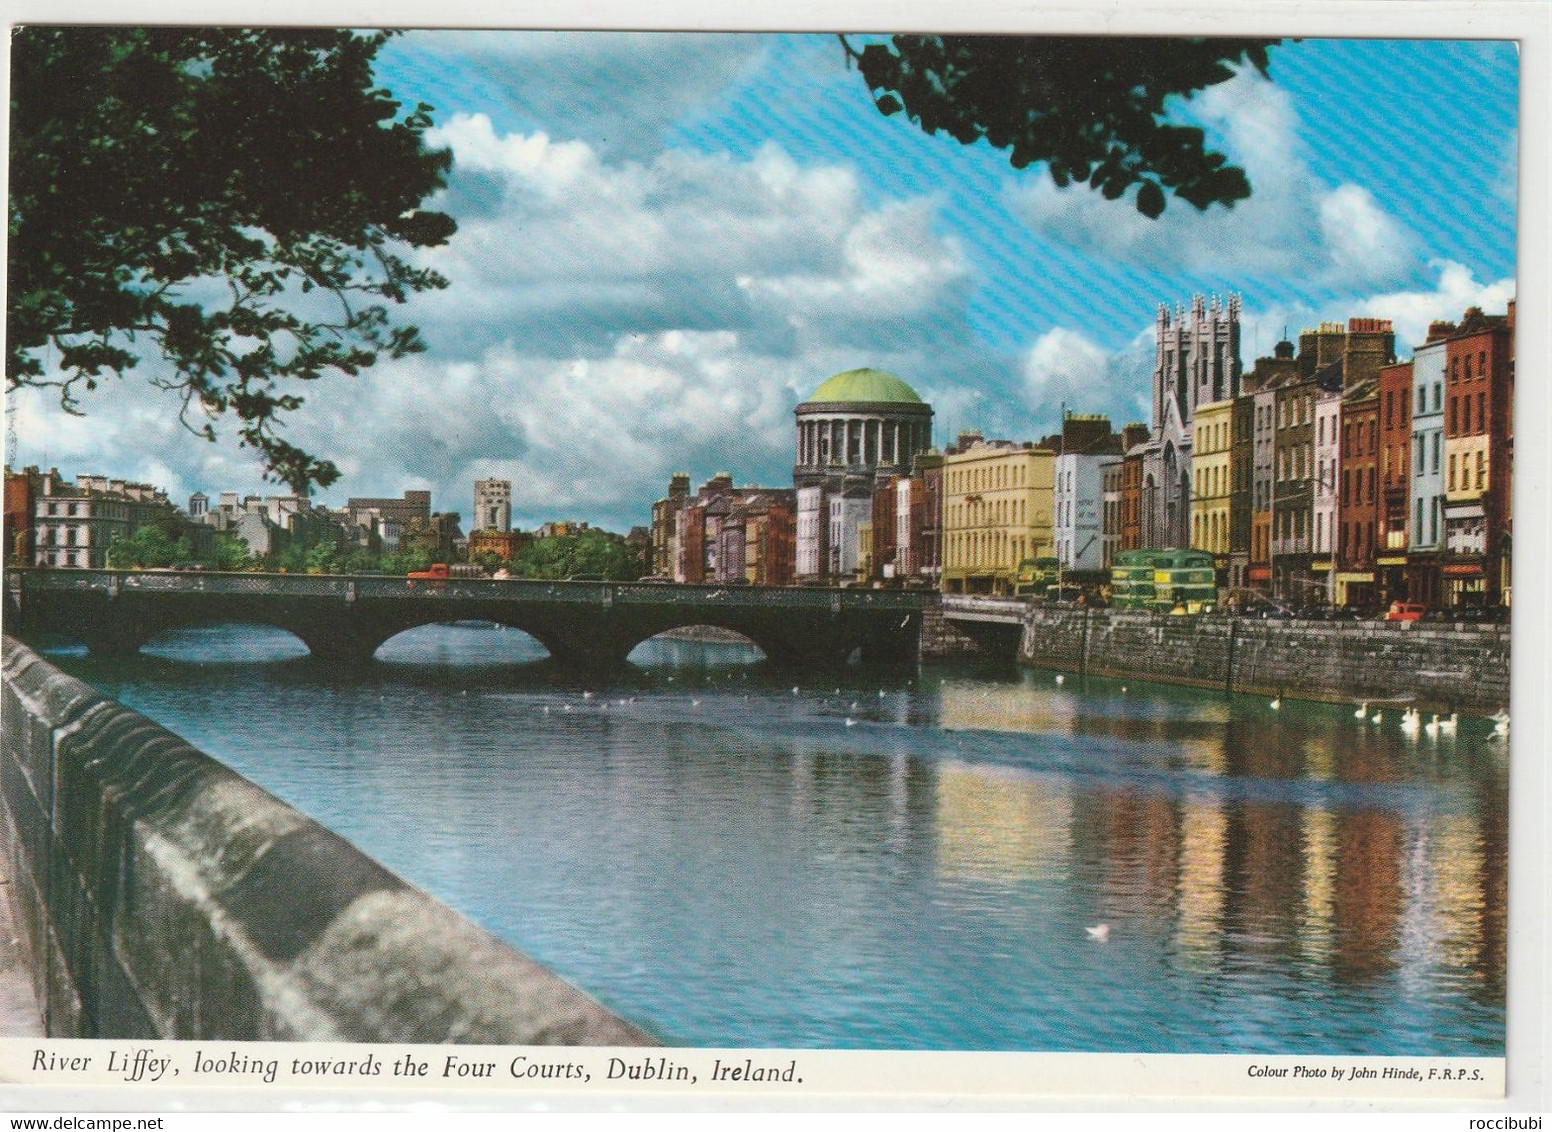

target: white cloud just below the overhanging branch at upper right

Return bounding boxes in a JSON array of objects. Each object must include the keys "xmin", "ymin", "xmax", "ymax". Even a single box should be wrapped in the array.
[{"xmin": 1007, "ymin": 68, "xmax": 1417, "ymax": 287}]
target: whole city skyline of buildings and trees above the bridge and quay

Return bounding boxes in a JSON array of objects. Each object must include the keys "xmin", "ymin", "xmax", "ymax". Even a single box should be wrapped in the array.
[{"xmin": 5, "ymin": 297, "xmax": 1515, "ymax": 630}]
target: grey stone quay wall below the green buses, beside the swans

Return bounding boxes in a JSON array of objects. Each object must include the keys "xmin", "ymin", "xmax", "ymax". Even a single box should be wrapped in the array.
[{"xmin": 1018, "ymin": 607, "xmax": 1509, "ymax": 714}]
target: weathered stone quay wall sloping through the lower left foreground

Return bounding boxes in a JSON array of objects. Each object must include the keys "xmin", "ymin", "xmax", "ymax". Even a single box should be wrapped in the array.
[{"xmin": 0, "ymin": 637, "xmax": 653, "ymax": 1045}]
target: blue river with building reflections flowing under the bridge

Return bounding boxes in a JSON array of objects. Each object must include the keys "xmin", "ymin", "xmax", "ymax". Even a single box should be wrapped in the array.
[{"xmin": 50, "ymin": 626, "xmax": 1509, "ymax": 1056}]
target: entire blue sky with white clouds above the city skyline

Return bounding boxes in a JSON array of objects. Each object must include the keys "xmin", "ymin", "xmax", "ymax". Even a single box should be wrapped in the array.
[{"xmin": 8, "ymin": 31, "xmax": 1518, "ymax": 531}]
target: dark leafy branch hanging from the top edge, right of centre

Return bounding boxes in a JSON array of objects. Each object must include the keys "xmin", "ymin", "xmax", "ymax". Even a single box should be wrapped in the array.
[{"xmin": 841, "ymin": 36, "xmax": 1279, "ymax": 217}]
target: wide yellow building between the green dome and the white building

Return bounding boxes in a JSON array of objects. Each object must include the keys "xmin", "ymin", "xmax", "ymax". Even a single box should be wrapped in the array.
[{"xmin": 942, "ymin": 435, "xmax": 1057, "ymax": 593}]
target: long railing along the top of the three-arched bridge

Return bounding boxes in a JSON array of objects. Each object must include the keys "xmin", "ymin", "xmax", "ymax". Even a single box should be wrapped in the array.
[{"xmin": 9, "ymin": 570, "xmax": 930, "ymax": 612}]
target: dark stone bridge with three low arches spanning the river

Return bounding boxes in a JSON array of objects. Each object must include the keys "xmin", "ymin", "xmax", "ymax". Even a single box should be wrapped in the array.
[{"xmin": 6, "ymin": 570, "xmax": 927, "ymax": 668}]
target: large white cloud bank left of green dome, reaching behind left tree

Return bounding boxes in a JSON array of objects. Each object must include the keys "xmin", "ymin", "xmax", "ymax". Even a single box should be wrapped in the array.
[{"xmin": 12, "ymin": 115, "xmax": 970, "ymax": 528}]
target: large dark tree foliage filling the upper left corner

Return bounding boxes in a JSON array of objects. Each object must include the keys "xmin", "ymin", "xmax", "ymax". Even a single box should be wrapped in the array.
[{"xmin": 6, "ymin": 26, "xmax": 455, "ymax": 492}]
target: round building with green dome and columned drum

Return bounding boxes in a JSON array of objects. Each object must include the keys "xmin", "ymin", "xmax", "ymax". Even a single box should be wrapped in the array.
[{"xmin": 792, "ymin": 370, "xmax": 933, "ymax": 581}]
